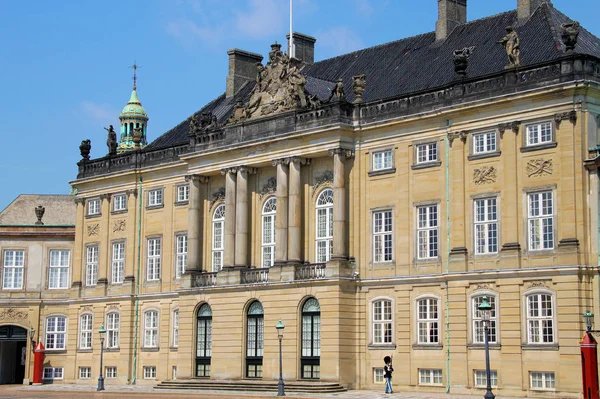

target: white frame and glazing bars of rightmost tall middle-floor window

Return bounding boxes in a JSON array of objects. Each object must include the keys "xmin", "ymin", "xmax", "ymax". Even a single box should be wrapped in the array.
[{"xmin": 524, "ymin": 187, "xmax": 558, "ymax": 253}]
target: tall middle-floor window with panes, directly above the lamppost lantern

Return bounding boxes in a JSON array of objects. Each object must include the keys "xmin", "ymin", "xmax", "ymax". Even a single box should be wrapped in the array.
[{"xmin": 474, "ymin": 197, "xmax": 498, "ymax": 255}]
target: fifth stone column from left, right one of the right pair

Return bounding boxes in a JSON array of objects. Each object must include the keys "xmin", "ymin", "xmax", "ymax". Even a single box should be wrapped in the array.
[{"xmin": 288, "ymin": 157, "xmax": 308, "ymax": 264}]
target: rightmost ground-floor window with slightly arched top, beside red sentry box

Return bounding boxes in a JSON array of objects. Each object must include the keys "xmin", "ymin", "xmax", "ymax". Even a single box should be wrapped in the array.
[{"xmin": 527, "ymin": 293, "xmax": 554, "ymax": 344}]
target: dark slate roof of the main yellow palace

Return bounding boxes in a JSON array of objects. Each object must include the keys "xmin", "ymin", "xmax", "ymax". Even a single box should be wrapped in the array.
[{"xmin": 146, "ymin": 2, "xmax": 600, "ymax": 149}]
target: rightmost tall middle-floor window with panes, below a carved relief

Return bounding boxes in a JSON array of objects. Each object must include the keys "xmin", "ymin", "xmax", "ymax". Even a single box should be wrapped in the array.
[{"xmin": 527, "ymin": 191, "xmax": 554, "ymax": 251}]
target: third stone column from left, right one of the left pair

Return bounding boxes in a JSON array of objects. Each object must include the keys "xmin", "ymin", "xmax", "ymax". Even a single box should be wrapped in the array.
[{"xmin": 236, "ymin": 166, "xmax": 256, "ymax": 267}]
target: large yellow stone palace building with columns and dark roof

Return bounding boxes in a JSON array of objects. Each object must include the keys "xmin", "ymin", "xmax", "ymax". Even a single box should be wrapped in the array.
[{"xmin": 0, "ymin": 0, "xmax": 600, "ymax": 398}]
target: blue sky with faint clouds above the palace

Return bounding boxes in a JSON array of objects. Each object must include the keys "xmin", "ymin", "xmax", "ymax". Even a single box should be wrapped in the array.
[{"xmin": 0, "ymin": 0, "xmax": 600, "ymax": 210}]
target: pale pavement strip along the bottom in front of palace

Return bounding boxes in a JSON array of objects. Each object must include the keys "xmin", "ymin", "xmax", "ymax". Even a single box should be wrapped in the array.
[{"xmin": 0, "ymin": 384, "xmax": 556, "ymax": 399}]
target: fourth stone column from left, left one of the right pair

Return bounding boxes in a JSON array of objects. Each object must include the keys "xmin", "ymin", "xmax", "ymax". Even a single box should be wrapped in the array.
[{"xmin": 273, "ymin": 158, "xmax": 289, "ymax": 266}]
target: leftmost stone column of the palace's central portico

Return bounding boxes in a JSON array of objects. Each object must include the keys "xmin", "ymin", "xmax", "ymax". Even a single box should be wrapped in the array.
[{"xmin": 185, "ymin": 175, "xmax": 208, "ymax": 272}]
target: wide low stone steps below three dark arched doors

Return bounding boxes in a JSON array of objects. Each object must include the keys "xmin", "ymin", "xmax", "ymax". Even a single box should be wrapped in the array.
[{"xmin": 154, "ymin": 378, "xmax": 346, "ymax": 393}]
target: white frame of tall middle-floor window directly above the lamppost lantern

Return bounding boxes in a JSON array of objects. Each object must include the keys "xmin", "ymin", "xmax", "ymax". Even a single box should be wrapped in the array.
[{"xmin": 472, "ymin": 194, "xmax": 501, "ymax": 257}]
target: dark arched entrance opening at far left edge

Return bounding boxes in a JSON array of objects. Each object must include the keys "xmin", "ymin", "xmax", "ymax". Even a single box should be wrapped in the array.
[{"xmin": 0, "ymin": 326, "xmax": 27, "ymax": 384}]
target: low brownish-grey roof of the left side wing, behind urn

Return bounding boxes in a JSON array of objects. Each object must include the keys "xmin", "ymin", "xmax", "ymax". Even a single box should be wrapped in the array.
[{"xmin": 0, "ymin": 194, "xmax": 76, "ymax": 226}]
